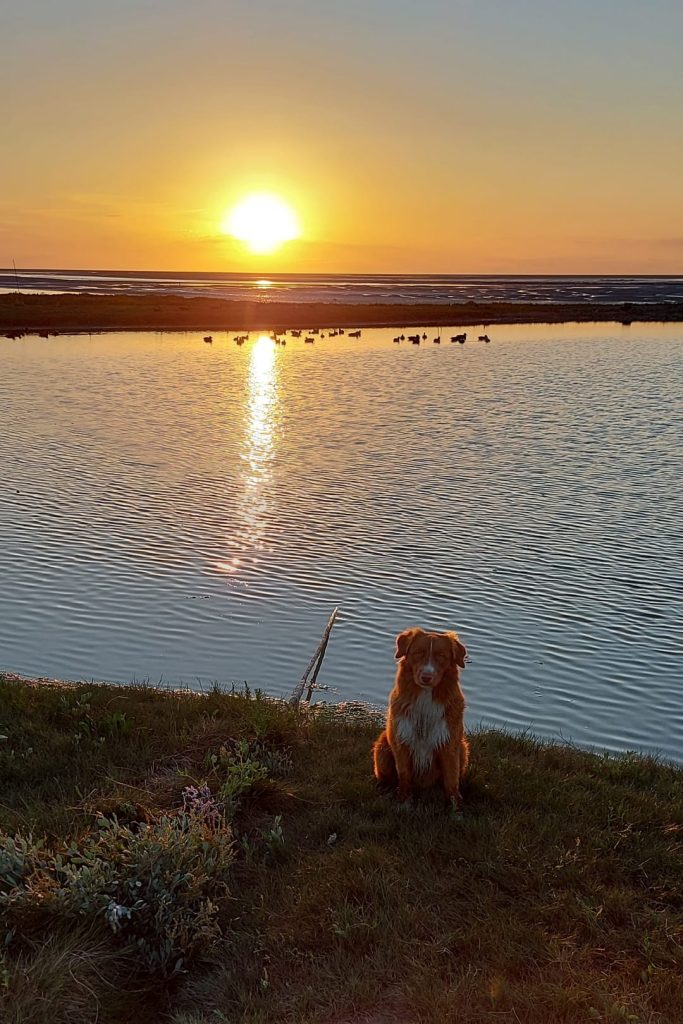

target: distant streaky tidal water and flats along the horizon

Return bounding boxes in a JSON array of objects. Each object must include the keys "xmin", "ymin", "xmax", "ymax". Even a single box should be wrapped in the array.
[{"xmin": 0, "ymin": 269, "xmax": 683, "ymax": 304}]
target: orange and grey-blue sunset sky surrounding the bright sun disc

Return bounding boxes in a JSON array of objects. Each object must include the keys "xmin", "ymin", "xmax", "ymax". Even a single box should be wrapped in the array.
[{"xmin": 0, "ymin": 0, "xmax": 683, "ymax": 273}]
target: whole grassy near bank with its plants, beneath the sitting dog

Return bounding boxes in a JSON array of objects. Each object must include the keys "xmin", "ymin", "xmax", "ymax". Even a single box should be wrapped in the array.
[{"xmin": 0, "ymin": 677, "xmax": 683, "ymax": 1024}]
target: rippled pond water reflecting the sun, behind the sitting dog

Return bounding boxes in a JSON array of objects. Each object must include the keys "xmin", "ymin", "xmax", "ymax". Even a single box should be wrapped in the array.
[{"xmin": 0, "ymin": 324, "xmax": 683, "ymax": 761}]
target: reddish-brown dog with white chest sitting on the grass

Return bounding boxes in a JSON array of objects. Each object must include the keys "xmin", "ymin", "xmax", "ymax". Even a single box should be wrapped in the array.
[{"xmin": 373, "ymin": 627, "xmax": 469, "ymax": 811}]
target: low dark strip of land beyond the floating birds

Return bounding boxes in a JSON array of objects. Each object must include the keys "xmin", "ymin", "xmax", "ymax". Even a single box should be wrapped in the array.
[{"xmin": 0, "ymin": 293, "xmax": 683, "ymax": 336}]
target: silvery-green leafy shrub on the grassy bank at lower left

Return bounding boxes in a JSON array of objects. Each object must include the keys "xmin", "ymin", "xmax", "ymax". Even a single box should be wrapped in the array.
[{"xmin": 0, "ymin": 811, "xmax": 233, "ymax": 976}]
